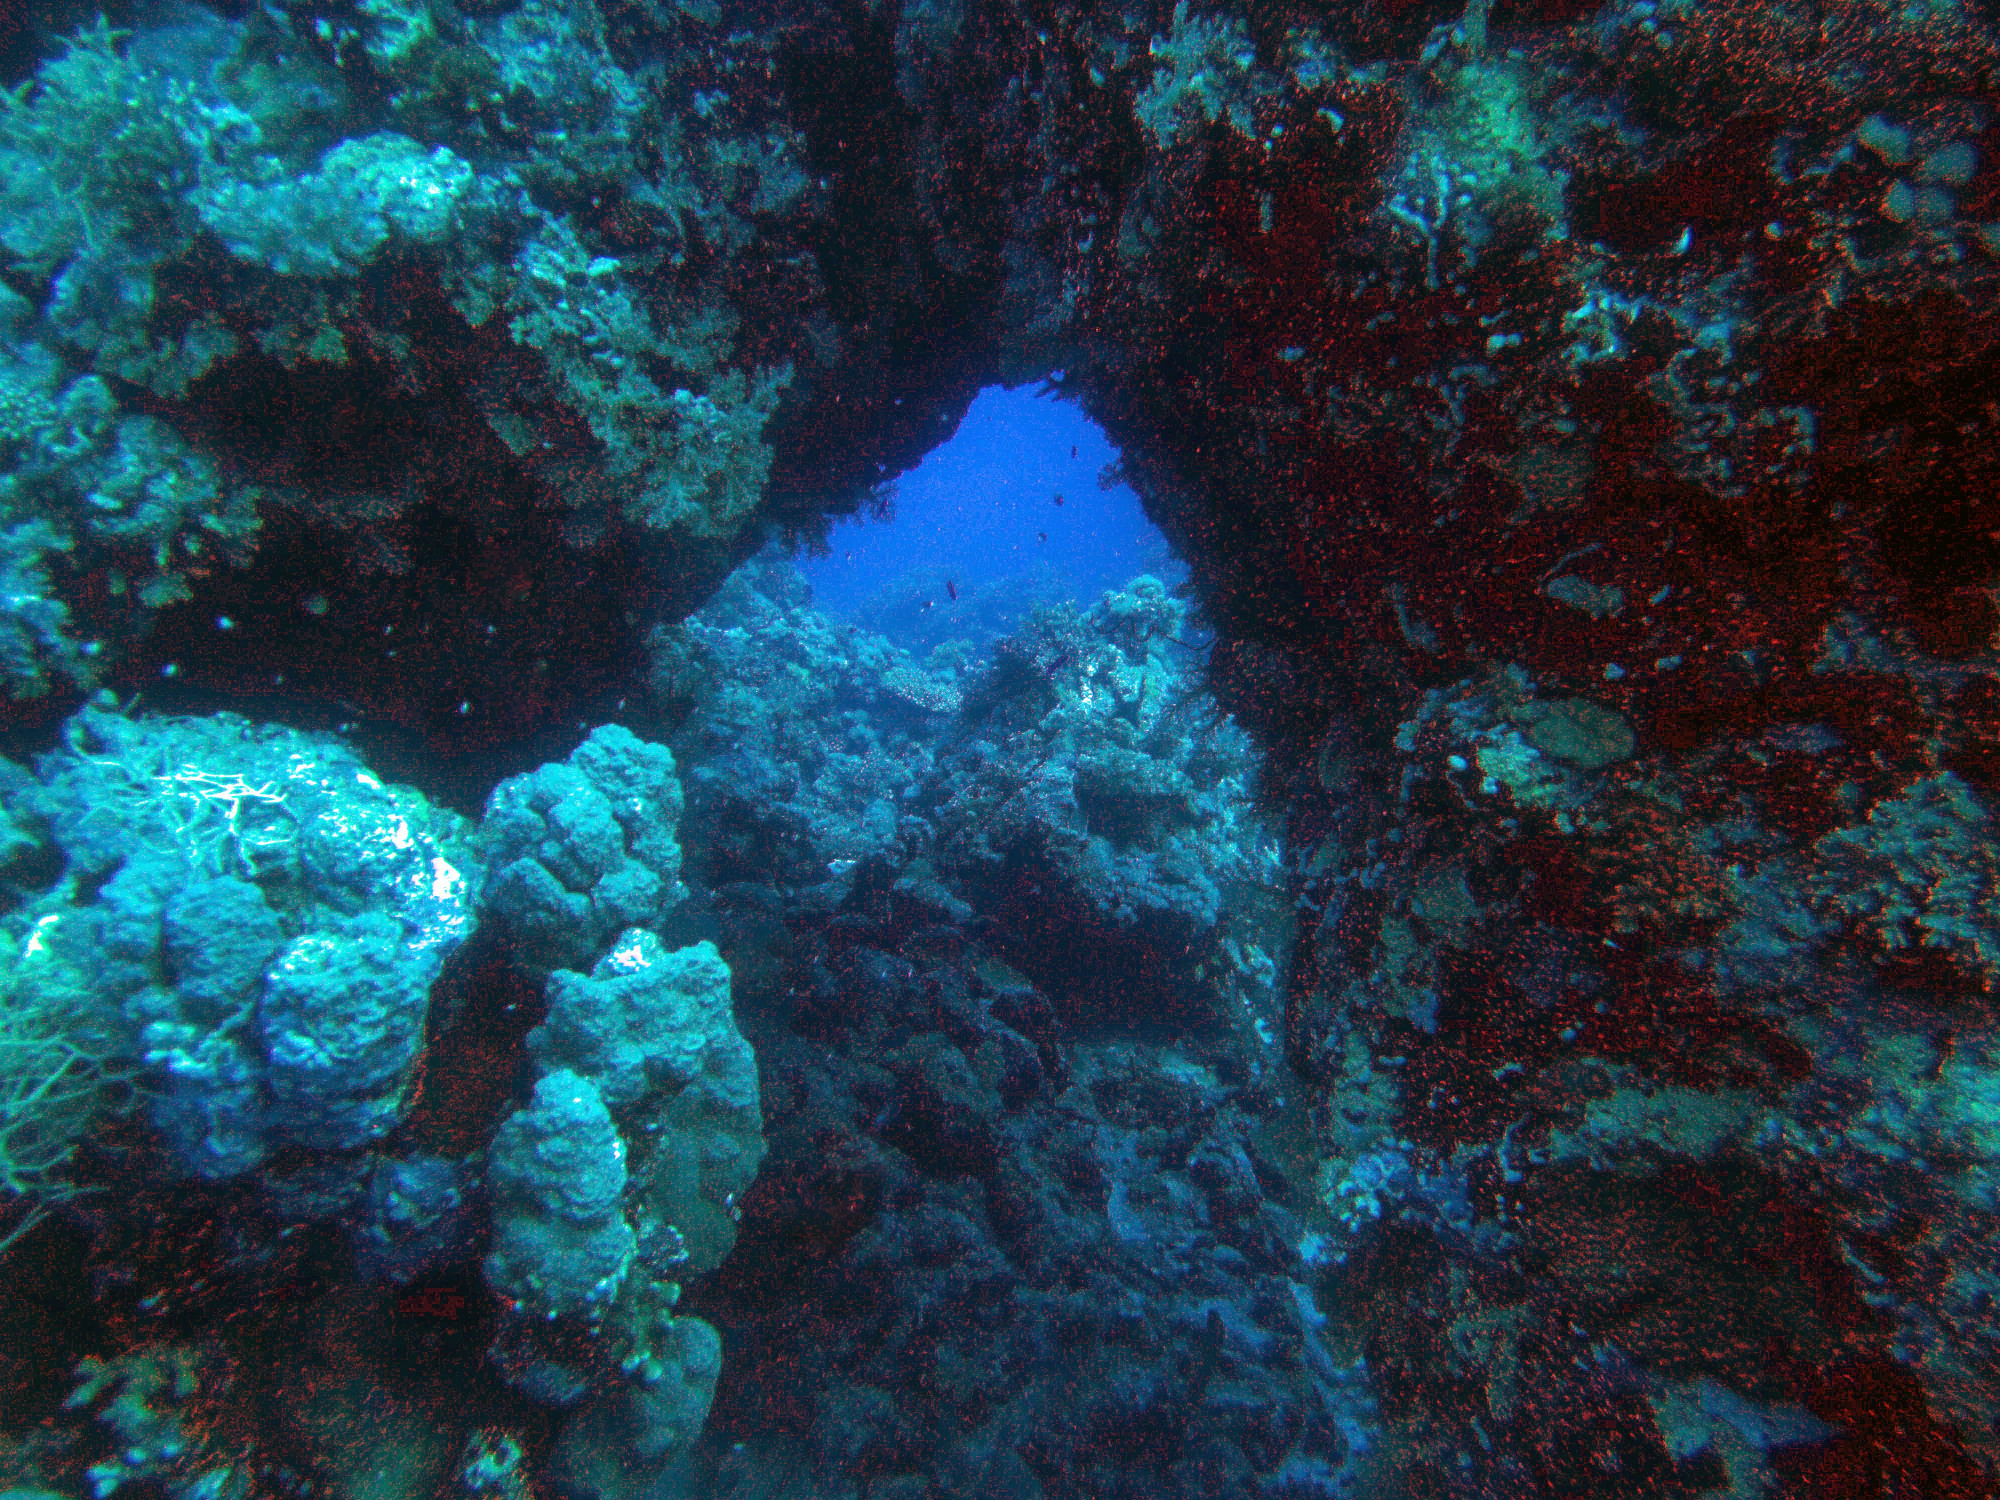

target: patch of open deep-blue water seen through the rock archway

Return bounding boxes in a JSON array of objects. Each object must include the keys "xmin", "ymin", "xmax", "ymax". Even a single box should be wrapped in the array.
[{"xmin": 800, "ymin": 386, "xmax": 1184, "ymax": 650}]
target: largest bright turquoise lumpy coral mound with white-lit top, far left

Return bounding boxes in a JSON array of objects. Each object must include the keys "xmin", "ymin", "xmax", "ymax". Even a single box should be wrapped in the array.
[{"xmin": 18, "ymin": 708, "xmax": 480, "ymax": 1178}]
